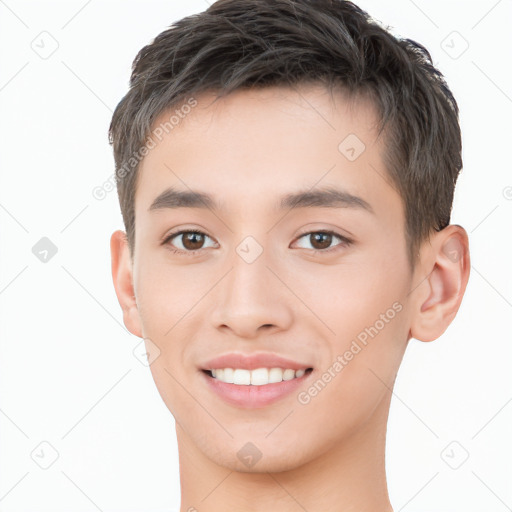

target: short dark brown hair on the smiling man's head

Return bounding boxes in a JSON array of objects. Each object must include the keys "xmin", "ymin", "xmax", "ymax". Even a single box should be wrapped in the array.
[{"xmin": 109, "ymin": 0, "xmax": 462, "ymax": 262}]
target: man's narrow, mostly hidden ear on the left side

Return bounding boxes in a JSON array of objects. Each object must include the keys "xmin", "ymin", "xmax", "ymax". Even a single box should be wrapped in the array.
[{"xmin": 110, "ymin": 230, "xmax": 143, "ymax": 338}]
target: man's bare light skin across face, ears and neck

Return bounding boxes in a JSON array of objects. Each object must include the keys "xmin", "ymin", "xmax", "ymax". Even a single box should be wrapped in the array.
[{"xmin": 111, "ymin": 85, "xmax": 469, "ymax": 512}]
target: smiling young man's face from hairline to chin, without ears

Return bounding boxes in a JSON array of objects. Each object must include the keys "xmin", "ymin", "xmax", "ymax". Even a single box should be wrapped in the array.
[{"xmin": 115, "ymin": 87, "xmax": 424, "ymax": 472}]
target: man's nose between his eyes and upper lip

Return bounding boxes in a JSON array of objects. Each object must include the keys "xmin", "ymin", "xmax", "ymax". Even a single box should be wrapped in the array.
[{"xmin": 212, "ymin": 251, "xmax": 293, "ymax": 339}]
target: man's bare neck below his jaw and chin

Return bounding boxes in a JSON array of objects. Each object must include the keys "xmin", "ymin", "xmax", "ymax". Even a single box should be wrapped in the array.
[{"xmin": 176, "ymin": 394, "xmax": 393, "ymax": 512}]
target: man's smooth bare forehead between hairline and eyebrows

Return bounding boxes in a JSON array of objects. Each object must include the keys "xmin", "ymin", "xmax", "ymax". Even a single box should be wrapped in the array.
[{"xmin": 135, "ymin": 86, "xmax": 400, "ymax": 217}]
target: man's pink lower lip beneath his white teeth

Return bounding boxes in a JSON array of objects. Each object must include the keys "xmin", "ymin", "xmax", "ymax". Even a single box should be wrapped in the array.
[{"xmin": 201, "ymin": 371, "xmax": 313, "ymax": 409}]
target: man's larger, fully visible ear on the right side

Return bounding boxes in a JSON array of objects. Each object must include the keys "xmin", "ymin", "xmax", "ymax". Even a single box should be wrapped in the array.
[{"xmin": 411, "ymin": 225, "xmax": 470, "ymax": 341}]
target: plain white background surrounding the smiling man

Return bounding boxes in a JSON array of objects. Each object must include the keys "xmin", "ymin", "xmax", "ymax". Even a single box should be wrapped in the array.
[{"xmin": 0, "ymin": 0, "xmax": 512, "ymax": 512}]
